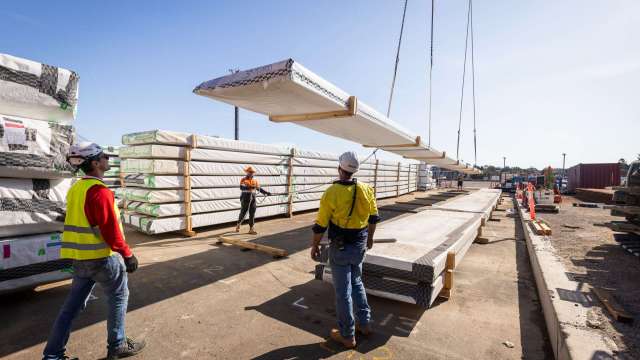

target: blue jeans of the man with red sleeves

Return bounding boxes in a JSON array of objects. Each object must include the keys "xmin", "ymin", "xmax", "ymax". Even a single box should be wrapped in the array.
[{"xmin": 43, "ymin": 254, "xmax": 129, "ymax": 359}]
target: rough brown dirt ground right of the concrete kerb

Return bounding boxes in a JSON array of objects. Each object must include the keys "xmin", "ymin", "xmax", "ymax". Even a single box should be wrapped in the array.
[{"xmin": 538, "ymin": 196, "xmax": 640, "ymax": 359}]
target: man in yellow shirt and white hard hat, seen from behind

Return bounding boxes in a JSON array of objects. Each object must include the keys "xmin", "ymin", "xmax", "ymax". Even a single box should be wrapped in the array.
[{"xmin": 311, "ymin": 151, "xmax": 380, "ymax": 348}]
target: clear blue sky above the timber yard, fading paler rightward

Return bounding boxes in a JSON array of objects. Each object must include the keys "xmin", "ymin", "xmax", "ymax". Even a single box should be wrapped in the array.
[{"xmin": 0, "ymin": 0, "xmax": 640, "ymax": 167}]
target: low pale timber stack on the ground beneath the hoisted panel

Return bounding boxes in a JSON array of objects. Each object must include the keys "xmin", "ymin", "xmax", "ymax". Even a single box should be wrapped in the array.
[{"xmin": 316, "ymin": 189, "xmax": 500, "ymax": 308}]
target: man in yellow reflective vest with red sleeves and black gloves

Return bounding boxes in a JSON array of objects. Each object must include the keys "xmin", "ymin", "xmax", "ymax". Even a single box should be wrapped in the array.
[{"xmin": 43, "ymin": 142, "xmax": 145, "ymax": 360}]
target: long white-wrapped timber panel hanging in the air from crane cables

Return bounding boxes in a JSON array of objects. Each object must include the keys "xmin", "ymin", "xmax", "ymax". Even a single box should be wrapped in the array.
[{"xmin": 193, "ymin": 59, "xmax": 480, "ymax": 172}]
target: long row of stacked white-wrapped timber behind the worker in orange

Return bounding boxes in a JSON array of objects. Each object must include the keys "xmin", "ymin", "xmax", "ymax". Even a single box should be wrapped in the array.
[{"xmin": 117, "ymin": 130, "xmax": 417, "ymax": 234}]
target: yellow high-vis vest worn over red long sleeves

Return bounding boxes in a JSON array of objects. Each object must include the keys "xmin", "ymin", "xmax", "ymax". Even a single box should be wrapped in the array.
[{"xmin": 60, "ymin": 178, "xmax": 124, "ymax": 260}]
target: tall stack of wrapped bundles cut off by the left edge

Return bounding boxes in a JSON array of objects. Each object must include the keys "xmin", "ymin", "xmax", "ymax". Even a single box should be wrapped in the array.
[{"xmin": 0, "ymin": 54, "xmax": 78, "ymax": 291}]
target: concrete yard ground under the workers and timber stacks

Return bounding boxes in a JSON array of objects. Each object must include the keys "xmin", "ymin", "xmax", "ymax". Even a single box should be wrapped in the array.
[{"xmin": 0, "ymin": 184, "xmax": 552, "ymax": 360}]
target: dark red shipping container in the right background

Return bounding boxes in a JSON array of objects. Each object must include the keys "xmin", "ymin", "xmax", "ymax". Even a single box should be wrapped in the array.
[{"xmin": 567, "ymin": 163, "xmax": 620, "ymax": 192}]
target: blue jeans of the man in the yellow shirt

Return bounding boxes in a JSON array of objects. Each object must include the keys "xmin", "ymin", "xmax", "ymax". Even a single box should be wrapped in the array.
[{"xmin": 329, "ymin": 237, "xmax": 371, "ymax": 338}]
